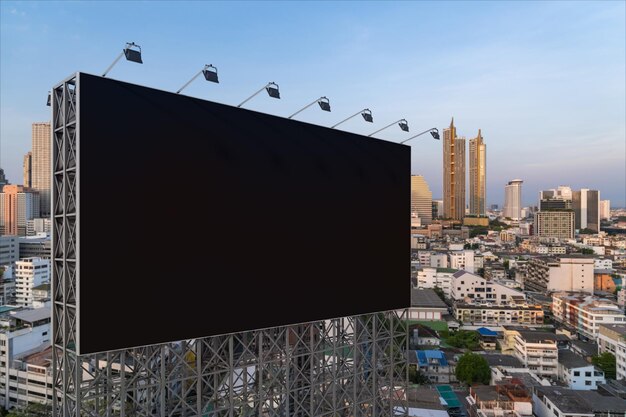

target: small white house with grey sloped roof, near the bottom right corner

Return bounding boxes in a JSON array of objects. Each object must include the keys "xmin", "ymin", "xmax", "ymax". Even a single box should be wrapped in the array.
[{"xmin": 558, "ymin": 350, "xmax": 606, "ymax": 390}]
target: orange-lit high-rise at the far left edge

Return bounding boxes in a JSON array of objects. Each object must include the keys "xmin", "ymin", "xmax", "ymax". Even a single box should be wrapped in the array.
[{"xmin": 0, "ymin": 185, "xmax": 40, "ymax": 236}]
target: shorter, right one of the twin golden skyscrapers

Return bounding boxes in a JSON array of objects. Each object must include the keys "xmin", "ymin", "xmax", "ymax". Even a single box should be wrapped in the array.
[{"xmin": 469, "ymin": 129, "xmax": 487, "ymax": 216}]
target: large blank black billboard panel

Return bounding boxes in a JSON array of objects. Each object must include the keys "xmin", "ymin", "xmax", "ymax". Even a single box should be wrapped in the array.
[{"xmin": 78, "ymin": 74, "xmax": 410, "ymax": 354}]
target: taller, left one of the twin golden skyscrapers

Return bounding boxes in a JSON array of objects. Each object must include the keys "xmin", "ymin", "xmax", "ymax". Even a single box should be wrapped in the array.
[{"xmin": 443, "ymin": 118, "xmax": 465, "ymax": 220}]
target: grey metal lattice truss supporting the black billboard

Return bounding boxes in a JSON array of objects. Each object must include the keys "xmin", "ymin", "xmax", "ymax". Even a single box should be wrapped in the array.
[{"xmin": 52, "ymin": 76, "xmax": 408, "ymax": 417}]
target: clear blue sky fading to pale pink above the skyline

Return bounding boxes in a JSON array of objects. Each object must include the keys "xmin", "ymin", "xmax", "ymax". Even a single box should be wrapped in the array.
[{"xmin": 0, "ymin": 1, "xmax": 626, "ymax": 206}]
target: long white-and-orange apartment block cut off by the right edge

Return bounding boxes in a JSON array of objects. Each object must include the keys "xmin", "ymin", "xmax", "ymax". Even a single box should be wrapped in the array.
[{"xmin": 552, "ymin": 292, "xmax": 626, "ymax": 340}]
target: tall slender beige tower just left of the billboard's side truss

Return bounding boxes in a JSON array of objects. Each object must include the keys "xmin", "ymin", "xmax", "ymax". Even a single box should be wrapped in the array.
[{"xmin": 31, "ymin": 122, "xmax": 52, "ymax": 217}]
